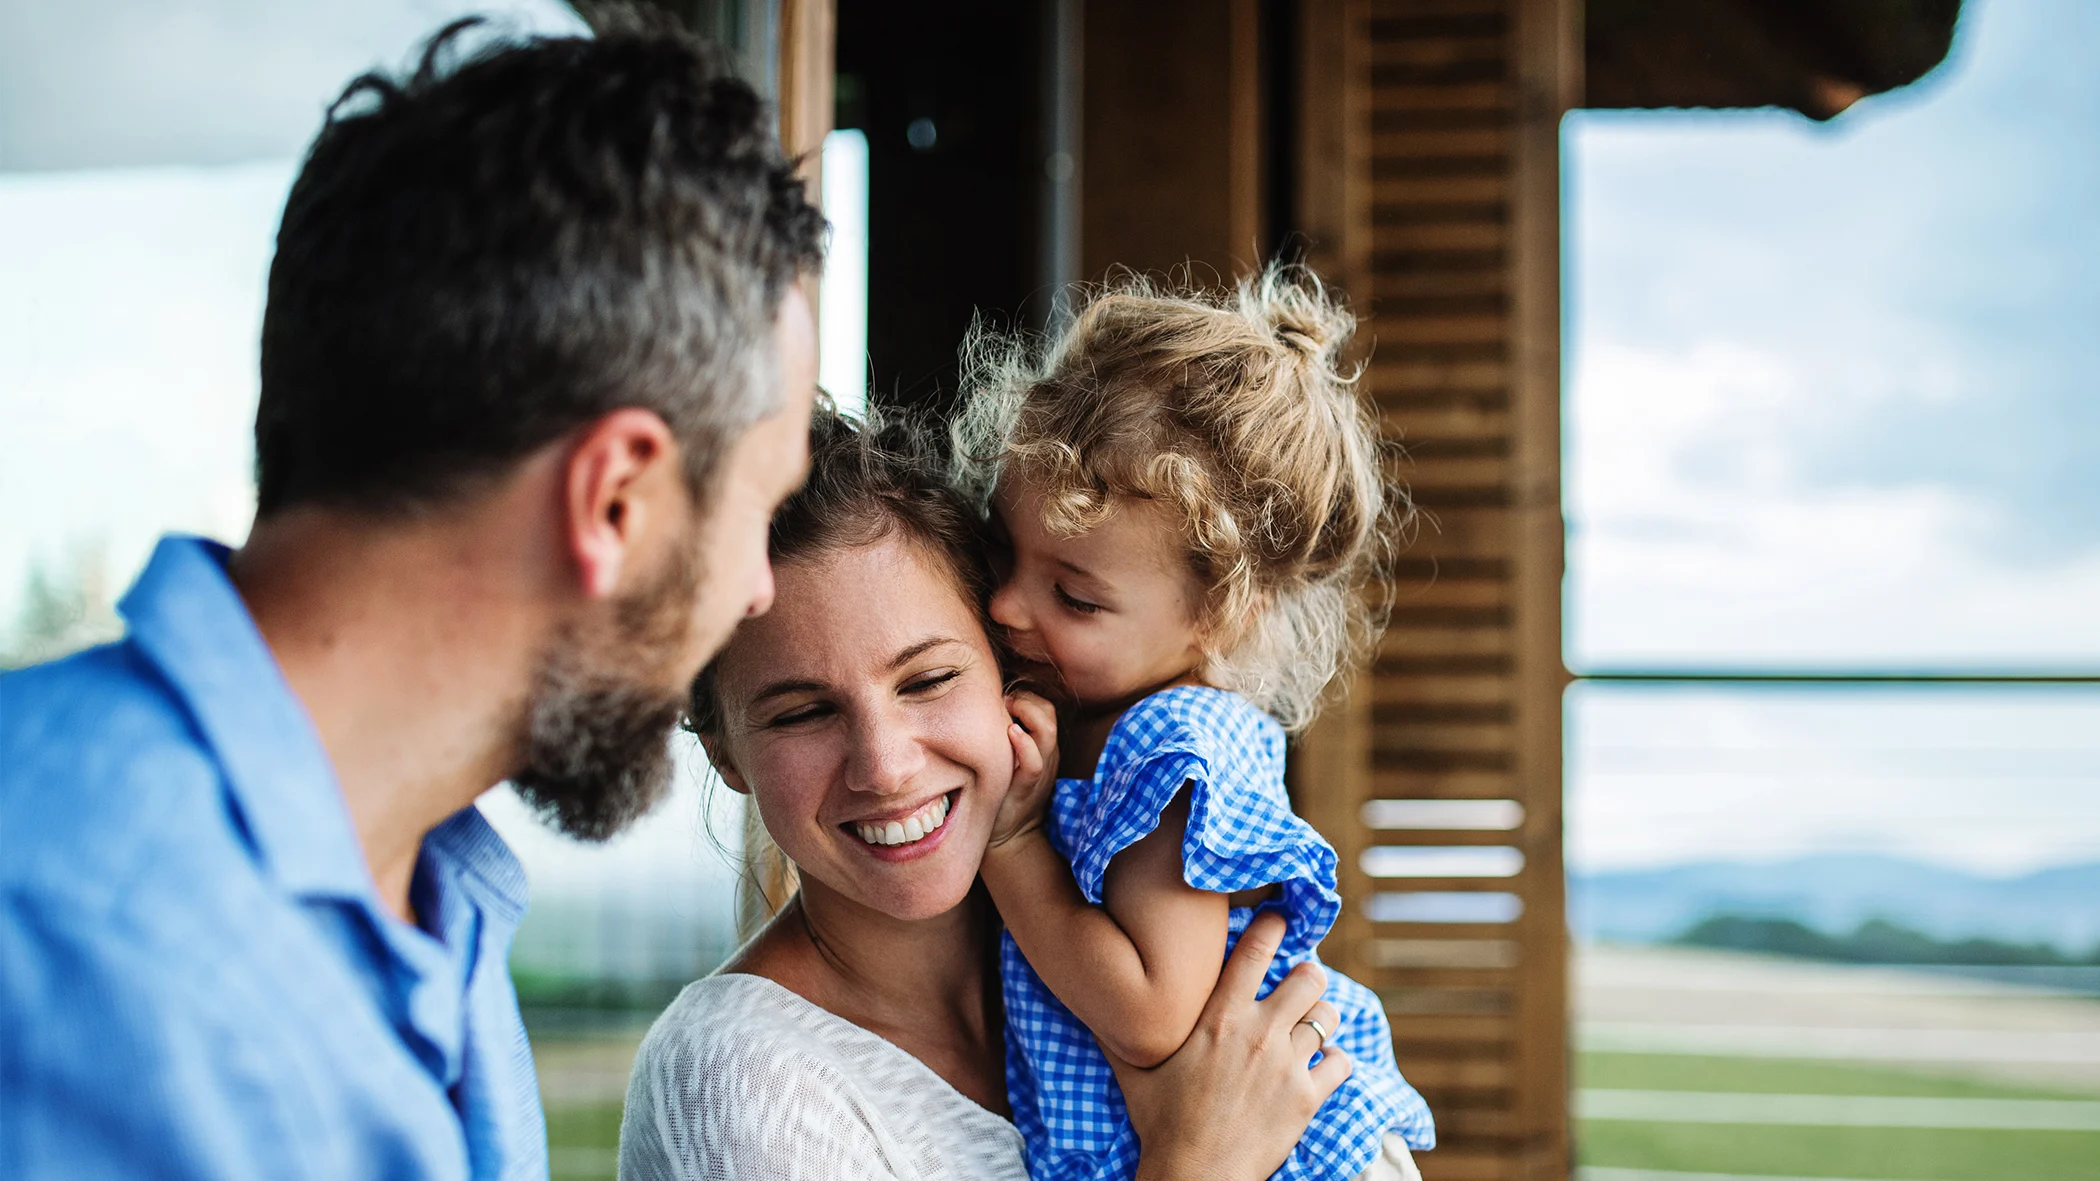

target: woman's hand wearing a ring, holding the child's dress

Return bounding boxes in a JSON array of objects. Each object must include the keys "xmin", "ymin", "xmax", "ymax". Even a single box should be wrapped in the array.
[{"xmin": 1109, "ymin": 912, "xmax": 1352, "ymax": 1181}]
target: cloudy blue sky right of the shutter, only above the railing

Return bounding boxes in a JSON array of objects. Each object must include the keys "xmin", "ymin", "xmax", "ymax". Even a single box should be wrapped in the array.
[{"xmin": 1565, "ymin": 0, "xmax": 2100, "ymax": 668}]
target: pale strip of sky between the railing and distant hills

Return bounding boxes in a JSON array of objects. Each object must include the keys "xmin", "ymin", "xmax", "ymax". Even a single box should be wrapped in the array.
[{"xmin": 1567, "ymin": 685, "xmax": 2100, "ymax": 874}]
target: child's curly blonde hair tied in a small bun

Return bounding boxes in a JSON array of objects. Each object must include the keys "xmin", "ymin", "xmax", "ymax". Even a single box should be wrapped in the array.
[{"xmin": 951, "ymin": 265, "xmax": 1411, "ymax": 731}]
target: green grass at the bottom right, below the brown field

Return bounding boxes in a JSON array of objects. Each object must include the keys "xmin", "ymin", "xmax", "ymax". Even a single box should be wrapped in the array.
[{"xmin": 1575, "ymin": 1053, "xmax": 2100, "ymax": 1181}]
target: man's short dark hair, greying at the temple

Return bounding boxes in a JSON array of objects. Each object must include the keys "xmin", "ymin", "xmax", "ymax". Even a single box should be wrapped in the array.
[{"xmin": 256, "ymin": 13, "xmax": 825, "ymax": 515}]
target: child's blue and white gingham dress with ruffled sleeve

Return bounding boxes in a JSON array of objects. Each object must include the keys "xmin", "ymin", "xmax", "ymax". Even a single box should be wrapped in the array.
[{"xmin": 1000, "ymin": 687, "xmax": 1436, "ymax": 1181}]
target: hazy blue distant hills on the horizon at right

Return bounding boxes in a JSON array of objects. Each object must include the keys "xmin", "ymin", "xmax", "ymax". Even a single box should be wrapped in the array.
[{"xmin": 1569, "ymin": 855, "xmax": 2100, "ymax": 956}]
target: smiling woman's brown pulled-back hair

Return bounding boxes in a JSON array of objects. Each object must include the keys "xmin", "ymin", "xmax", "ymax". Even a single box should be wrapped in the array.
[{"xmin": 687, "ymin": 406, "xmax": 993, "ymax": 738}]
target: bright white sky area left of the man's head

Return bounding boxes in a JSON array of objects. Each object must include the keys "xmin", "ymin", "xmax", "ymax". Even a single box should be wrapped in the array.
[{"xmin": 0, "ymin": 160, "xmax": 294, "ymax": 626}]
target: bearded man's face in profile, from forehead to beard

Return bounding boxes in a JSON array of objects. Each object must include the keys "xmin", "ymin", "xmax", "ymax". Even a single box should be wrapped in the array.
[{"xmin": 512, "ymin": 288, "xmax": 817, "ymax": 841}]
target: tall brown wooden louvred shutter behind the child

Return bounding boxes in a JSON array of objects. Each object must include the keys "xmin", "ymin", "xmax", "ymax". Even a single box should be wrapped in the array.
[{"xmin": 1298, "ymin": 0, "xmax": 1579, "ymax": 1181}]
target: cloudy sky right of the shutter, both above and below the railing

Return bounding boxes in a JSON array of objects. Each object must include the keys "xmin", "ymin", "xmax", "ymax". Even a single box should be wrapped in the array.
[{"xmin": 1562, "ymin": 0, "xmax": 2100, "ymax": 874}]
